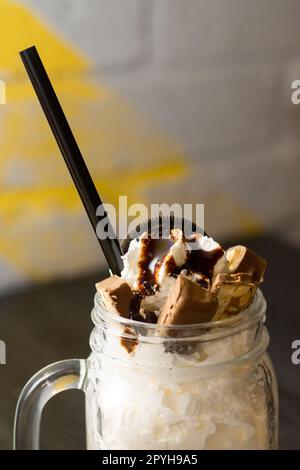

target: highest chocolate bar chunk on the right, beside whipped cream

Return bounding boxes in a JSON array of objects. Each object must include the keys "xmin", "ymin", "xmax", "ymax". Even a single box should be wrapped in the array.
[{"xmin": 226, "ymin": 245, "xmax": 267, "ymax": 283}]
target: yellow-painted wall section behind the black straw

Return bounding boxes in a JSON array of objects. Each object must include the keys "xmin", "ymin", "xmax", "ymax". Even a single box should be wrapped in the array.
[{"xmin": 0, "ymin": 0, "xmax": 186, "ymax": 289}]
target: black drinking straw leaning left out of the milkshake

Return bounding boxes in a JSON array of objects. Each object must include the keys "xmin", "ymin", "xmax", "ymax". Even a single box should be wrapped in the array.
[{"xmin": 20, "ymin": 46, "xmax": 123, "ymax": 275}]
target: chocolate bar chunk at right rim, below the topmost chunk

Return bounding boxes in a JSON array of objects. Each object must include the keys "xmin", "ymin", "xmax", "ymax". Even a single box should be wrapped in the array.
[{"xmin": 211, "ymin": 273, "xmax": 257, "ymax": 320}]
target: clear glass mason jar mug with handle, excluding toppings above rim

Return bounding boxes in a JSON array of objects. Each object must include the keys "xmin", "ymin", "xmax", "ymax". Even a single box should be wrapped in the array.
[{"xmin": 15, "ymin": 291, "xmax": 278, "ymax": 450}]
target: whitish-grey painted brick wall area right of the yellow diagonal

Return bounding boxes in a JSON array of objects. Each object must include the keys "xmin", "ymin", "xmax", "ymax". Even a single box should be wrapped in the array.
[{"xmin": 15, "ymin": 0, "xmax": 300, "ymax": 237}]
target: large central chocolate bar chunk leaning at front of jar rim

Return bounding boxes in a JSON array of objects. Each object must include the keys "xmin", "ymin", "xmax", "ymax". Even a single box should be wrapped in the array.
[{"xmin": 158, "ymin": 275, "xmax": 218, "ymax": 325}]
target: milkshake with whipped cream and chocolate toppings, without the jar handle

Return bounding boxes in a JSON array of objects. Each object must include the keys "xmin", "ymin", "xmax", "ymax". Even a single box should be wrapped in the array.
[{"xmin": 84, "ymin": 229, "xmax": 278, "ymax": 450}]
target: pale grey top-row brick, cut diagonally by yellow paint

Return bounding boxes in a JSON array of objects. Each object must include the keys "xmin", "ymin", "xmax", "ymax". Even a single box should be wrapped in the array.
[{"xmin": 20, "ymin": 0, "xmax": 147, "ymax": 68}]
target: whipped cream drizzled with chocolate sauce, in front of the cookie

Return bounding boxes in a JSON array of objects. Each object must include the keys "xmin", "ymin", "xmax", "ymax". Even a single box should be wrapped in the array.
[{"xmin": 121, "ymin": 229, "xmax": 227, "ymax": 314}]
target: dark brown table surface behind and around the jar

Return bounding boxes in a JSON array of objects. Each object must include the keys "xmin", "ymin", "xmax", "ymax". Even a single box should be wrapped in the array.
[{"xmin": 0, "ymin": 235, "xmax": 300, "ymax": 449}]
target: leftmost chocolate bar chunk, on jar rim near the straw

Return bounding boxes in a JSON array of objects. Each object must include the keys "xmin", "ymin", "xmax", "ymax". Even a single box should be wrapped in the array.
[{"xmin": 96, "ymin": 275, "xmax": 133, "ymax": 318}]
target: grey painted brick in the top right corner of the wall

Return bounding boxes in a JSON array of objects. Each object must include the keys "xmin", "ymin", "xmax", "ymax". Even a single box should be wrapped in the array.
[{"xmin": 154, "ymin": 0, "xmax": 300, "ymax": 67}]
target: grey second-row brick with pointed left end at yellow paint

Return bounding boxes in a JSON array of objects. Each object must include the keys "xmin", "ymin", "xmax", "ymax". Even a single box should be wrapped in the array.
[{"xmin": 106, "ymin": 65, "xmax": 277, "ymax": 152}]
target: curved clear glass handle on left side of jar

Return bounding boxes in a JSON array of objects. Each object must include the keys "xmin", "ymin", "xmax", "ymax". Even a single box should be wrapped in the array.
[{"xmin": 14, "ymin": 359, "xmax": 85, "ymax": 450}]
